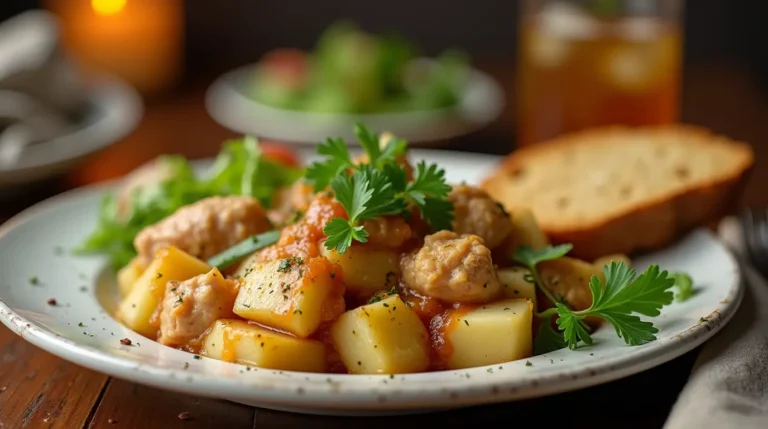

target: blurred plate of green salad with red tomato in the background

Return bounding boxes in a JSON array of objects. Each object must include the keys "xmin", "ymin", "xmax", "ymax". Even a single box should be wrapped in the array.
[{"xmin": 207, "ymin": 22, "xmax": 504, "ymax": 143}]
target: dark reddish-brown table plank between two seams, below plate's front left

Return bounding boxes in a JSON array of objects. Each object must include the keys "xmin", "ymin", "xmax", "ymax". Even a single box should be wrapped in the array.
[{"xmin": 89, "ymin": 379, "xmax": 254, "ymax": 429}]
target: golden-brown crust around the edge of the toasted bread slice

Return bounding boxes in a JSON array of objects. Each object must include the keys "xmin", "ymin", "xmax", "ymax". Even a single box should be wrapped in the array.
[{"xmin": 481, "ymin": 125, "xmax": 754, "ymax": 261}]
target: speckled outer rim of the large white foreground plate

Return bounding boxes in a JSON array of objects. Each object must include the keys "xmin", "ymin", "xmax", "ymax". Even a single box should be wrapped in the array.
[{"xmin": 0, "ymin": 165, "xmax": 744, "ymax": 413}]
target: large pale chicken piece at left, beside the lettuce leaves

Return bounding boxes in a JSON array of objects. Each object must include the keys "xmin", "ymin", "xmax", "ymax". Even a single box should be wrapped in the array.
[{"xmin": 133, "ymin": 196, "xmax": 271, "ymax": 264}]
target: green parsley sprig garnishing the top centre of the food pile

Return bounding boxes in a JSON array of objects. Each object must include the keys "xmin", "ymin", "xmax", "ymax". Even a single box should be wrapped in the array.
[{"xmin": 306, "ymin": 123, "xmax": 453, "ymax": 253}]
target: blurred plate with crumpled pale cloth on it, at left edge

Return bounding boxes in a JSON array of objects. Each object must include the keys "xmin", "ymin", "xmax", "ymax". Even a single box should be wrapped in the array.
[{"xmin": 0, "ymin": 10, "xmax": 142, "ymax": 193}]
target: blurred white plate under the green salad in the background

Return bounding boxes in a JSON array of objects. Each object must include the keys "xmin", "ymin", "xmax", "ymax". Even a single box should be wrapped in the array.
[{"xmin": 206, "ymin": 62, "xmax": 504, "ymax": 146}]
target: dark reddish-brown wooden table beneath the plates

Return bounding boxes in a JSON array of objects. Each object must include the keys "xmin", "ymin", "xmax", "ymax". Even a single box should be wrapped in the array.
[{"xmin": 0, "ymin": 66, "xmax": 768, "ymax": 429}]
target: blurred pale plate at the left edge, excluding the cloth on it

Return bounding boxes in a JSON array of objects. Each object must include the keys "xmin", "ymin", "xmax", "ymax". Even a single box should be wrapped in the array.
[{"xmin": 0, "ymin": 75, "xmax": 143, "ymax": 190}]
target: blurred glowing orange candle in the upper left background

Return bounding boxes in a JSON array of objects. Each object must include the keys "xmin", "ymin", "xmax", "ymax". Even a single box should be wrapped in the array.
[{"xmin": 45, "ymin": 0, "xmax": 184, "ymax": 94}]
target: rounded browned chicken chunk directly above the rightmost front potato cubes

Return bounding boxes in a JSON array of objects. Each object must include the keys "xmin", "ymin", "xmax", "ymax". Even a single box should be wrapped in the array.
[{"xmin": 400, "ymin": 231, "xmax": 501, "ymax": 303}]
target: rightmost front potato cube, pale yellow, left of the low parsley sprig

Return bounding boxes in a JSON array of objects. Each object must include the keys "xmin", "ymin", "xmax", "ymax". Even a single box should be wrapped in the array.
[{"xmin": 433, "ymin": 299, "xmax": 533, "ymax": 369}]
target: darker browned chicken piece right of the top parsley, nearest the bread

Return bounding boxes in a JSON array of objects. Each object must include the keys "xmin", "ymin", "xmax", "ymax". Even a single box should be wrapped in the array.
[{"xmin": 448, "ymin": 185, "xmax": 512, "ymax": 249}]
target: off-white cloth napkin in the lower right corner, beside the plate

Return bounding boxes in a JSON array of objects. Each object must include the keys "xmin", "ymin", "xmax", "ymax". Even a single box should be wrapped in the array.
[{"xmin": 664, "ymin": 218, "xmax": 768, "ymax": 429}]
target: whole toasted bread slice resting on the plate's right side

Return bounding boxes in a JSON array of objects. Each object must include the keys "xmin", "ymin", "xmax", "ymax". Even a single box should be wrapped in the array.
[{"xmin": 482, "ymin": 125, "xmax": 753, "ymax": 260}]
